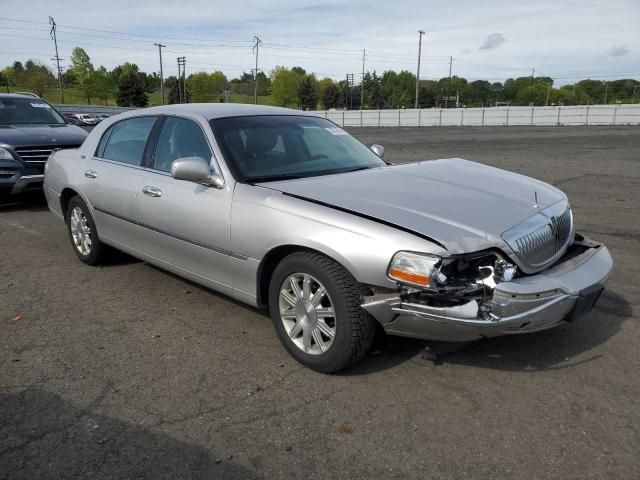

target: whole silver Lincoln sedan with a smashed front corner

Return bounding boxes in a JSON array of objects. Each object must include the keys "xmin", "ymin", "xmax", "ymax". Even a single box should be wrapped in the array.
[{"xmin": 45, "ymin": 104, "xmax": 613, "ymax": 372}]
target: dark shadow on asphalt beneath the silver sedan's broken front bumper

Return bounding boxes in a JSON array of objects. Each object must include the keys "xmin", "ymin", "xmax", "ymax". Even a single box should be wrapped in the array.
[{"xmin": 342, "ymin": 290, "xmax": 633, "ymax": 375}]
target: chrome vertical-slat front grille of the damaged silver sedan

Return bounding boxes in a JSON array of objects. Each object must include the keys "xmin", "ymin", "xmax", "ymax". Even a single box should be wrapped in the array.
[{"xmin": 502, "ymin": 202, "xmax": 573, "ymax": 269}]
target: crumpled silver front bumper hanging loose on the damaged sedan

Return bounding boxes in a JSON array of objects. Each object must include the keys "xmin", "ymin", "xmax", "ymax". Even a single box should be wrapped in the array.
[{"xmin": 362, "ymin": 241, "xmax": 613, "ymax": 342}]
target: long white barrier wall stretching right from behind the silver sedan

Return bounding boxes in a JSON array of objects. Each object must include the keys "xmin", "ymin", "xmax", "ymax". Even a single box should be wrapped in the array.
[{"xmin": 314, "ymin": 104, "xmax": 640, "ymax": 127}]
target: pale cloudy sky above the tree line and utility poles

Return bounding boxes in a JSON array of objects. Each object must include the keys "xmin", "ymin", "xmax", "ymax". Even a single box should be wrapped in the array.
[{"xmin": 0, "ymin": 0, "xmax": 640, "ymax": 85}]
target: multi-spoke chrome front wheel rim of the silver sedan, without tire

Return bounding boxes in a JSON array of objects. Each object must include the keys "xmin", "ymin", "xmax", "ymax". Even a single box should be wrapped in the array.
[{"xmin": 279, "ymin": 273, "xmax": 336, "ymax": 355}]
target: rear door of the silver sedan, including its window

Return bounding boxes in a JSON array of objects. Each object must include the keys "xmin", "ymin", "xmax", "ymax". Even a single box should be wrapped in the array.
[{"xmin": 80, "ymin": 116, "xmax": 158, "ymax": 252}]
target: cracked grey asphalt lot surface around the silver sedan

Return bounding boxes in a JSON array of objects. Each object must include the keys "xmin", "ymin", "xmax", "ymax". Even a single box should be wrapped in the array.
[{"xmin": 0, "ymin": 127, "xmax": 640, "ymax": 480}]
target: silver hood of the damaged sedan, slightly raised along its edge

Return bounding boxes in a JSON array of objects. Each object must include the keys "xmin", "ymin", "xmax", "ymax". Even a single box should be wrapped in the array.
[{"xmin": 261, "ymin": 158, "xmax": 566, "ymax": 254}]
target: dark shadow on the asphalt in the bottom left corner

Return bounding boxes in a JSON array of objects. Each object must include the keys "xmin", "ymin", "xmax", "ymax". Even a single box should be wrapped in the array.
[{"xmin": 0, "ymin": 385, "xmax": 259, "ymax": 480}]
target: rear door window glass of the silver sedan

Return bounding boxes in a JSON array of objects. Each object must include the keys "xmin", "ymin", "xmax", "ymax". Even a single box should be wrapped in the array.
[{"xmin": 96, "ymin": 117, "xmax": 156, "ymax": 165}]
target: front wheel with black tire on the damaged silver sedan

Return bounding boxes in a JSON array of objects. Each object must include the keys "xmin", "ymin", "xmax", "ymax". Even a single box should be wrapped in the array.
[{"xmin": 269, "ymin": 252, "xmax": 376, "ymax": 373}]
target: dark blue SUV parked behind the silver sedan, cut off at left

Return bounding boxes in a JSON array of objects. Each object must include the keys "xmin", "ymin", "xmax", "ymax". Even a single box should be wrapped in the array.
[{"xmin": 0, "ymin": 94, "xmax": 87, "ymax": 195}]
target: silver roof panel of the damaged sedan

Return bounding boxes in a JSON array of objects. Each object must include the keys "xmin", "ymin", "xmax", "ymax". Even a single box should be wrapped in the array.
[{"xmin": 136, "ymin": 103, "xmax": 313, "ymax": 120}]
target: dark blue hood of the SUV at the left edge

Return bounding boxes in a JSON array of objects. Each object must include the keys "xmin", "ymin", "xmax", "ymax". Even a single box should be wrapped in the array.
[{"xmin": 0, "ymin": 123, "xmax": 87, "ymax": 147}]
